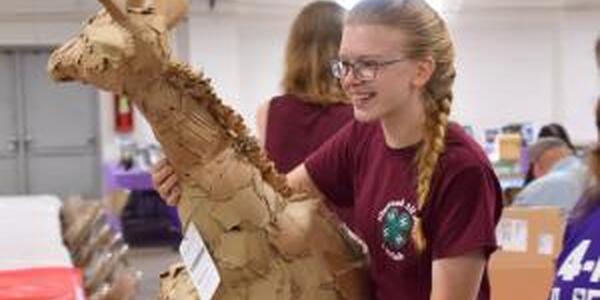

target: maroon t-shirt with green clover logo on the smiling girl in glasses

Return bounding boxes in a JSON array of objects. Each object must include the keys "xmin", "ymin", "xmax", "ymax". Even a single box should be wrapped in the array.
[{"xmin": 305, "ymin": 121, "xmax": 502, "ymax": 300}]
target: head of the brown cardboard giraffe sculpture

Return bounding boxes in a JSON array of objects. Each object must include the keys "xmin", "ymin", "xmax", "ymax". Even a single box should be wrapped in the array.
[{"xmin": 48, "ymin": 0, "xmax": 188, "ymax": 94}]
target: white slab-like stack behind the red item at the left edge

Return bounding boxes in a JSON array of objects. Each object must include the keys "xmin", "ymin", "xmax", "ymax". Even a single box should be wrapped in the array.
[{"xmin": 0, "ymin": 195, "xmax": 73, "ymax": 271}]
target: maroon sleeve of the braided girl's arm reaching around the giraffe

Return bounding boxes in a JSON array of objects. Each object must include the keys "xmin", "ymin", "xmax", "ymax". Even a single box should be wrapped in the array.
[{"xmin": 304, "ymin": 122, "xmax": 354, "ymax": 206}]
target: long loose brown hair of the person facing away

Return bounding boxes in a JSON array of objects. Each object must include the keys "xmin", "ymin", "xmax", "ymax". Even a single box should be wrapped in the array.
[{"xmin": 282, "ymin": 1, "xmax": 347, "ymax": 104}]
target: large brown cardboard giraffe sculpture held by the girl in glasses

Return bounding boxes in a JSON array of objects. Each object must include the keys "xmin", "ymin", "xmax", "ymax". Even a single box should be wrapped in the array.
[{"xmin": 48, "ymin": 0, "xmax": 369, "ymax": 300}]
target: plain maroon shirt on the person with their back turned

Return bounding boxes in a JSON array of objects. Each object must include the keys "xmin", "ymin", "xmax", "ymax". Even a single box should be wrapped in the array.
[{"xmin": 265, "ymin": 95, "xmax": 352, "ymax": 174}]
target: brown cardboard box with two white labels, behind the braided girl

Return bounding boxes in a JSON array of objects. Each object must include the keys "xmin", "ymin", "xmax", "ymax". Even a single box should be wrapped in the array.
[{"xmin": 488, "ymin": 207, "xmax": 564, "ymax": 300}]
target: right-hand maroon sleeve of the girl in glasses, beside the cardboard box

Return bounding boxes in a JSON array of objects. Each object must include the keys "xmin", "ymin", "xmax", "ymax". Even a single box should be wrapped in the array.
[{"xmin": 431, "ymin": 166, "xmax": 502, "ymax": 259}]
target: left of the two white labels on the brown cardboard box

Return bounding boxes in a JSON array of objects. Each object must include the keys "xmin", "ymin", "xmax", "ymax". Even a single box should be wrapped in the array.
[{"xmin": 496, "ymin": 219, "xmax": 527, "ymax": 252}]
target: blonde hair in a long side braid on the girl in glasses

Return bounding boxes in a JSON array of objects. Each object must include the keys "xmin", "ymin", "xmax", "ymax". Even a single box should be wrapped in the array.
[{"xmin": 346, "ymin": 0, "xmax": 456, "ymax": 252}]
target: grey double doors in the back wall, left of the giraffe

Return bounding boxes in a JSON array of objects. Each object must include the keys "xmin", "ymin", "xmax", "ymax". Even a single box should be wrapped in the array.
[{"xmin": 0, "ymin": 50, "xmax": 101, "ymax": 197}]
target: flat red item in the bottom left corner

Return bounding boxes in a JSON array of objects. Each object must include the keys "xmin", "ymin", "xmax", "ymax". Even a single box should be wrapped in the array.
[{"xmin": 0, "ymin": 268, "xmax": 85, "ymax": 300}]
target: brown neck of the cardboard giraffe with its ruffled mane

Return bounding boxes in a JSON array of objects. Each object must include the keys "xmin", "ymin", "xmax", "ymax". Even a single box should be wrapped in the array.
[{"xmin": 130, "ymin": 62, "xmax": 291, "ymax": 196}]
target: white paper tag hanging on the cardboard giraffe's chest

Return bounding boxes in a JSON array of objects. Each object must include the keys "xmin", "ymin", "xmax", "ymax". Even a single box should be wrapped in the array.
[{"xmin": 179, "ymin": 224, "xmax": 221, "ymax": 300}]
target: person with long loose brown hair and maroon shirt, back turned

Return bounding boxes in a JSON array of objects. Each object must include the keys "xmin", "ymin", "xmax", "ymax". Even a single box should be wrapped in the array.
[{"xmin": 257, "ymin": 1, "xmax": 352, "ymax": 173}]
